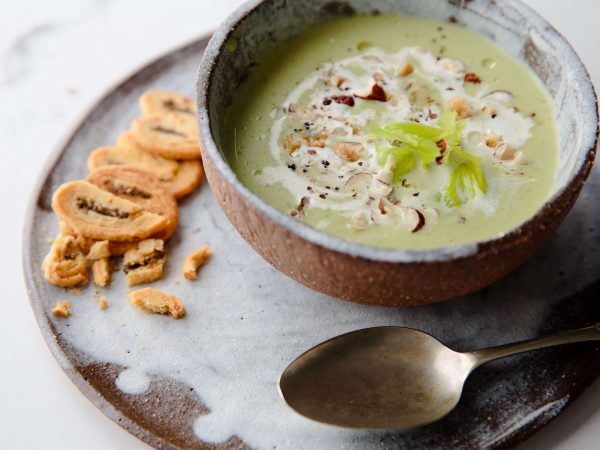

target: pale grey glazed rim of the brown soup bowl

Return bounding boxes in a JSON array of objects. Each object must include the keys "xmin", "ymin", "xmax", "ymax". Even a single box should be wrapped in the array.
[{"xmin": 196, "ymin": 0, "xmax": 600, "ymax": 263}]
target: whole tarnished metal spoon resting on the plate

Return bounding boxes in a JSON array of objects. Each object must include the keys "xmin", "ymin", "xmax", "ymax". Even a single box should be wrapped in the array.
[{"xmin": 279, "ymin": 323, "xmax": 600, "ymax": 429}]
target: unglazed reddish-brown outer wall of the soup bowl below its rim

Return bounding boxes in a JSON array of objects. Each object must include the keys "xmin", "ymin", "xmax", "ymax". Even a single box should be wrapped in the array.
[{"xmin": 202, "ymin": 142, "xmax": 593, "ymax": 306}]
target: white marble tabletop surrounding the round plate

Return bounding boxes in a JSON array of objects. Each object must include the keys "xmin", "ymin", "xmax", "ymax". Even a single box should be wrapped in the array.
[{"xmin": 0, "ymin": 0, "xmax": 600, "ymax": 450}]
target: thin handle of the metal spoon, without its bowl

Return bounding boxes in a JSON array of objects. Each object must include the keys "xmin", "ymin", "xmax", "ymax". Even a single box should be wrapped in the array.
[{"xmin": 470, "ymin": 322, "xmax": 600, "ymax": 367}]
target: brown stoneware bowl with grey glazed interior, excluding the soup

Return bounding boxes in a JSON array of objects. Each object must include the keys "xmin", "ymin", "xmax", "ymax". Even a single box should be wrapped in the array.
[{"xmin": 197, "ymin": 0, "xmax": 598, "ymax": 306}]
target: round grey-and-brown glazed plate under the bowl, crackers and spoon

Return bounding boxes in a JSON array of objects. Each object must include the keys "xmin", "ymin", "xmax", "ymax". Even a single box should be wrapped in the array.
[{"xmin": 23, "ymin": 32, "xmax": 600, "ymax": 449}]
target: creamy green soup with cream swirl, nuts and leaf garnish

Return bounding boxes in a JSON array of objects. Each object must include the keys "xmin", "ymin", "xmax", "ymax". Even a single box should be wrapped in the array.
[{"xmin": 225, "ymin": 15, "xmax": 558, "ymax": 249}]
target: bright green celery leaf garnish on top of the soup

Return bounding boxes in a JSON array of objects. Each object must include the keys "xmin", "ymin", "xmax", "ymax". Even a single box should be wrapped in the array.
[{"xmin": 373, "ymin": 110, "xmax": 487, "ymax": 208}]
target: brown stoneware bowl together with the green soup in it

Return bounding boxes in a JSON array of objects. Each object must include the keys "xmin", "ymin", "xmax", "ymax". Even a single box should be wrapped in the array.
[{"xmin": 198, "ymin": 0, "xmax": 598, "ymax": 305}]
